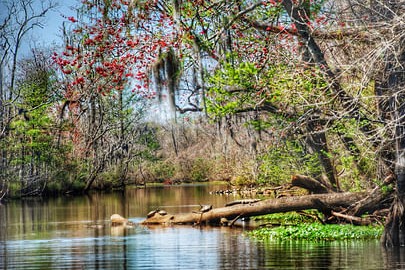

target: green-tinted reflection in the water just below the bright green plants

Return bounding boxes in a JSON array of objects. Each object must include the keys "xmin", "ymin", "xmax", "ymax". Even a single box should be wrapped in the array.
[{"xmin": 249, "ymin": 241, "xmax": 384, "ymax": 269}]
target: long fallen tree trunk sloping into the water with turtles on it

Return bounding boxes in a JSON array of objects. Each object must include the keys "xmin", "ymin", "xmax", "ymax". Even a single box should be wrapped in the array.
[{"xmin": 142, "ymin": 192, "xmax": 367, "ymax": 225}]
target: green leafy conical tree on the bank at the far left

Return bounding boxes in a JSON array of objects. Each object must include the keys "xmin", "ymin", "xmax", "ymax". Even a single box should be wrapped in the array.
[{"xmin": 0, "ymin": 58, "xmax": 77, "ymax": 196}]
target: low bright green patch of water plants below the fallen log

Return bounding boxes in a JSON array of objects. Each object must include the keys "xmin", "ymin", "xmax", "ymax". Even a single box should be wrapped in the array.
[{"xmin": 248, "ymin": 223, "xmax": 384, "ymax": 241}]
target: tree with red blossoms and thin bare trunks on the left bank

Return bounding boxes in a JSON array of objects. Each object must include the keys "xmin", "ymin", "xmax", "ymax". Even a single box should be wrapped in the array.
[{"xmin": 53, "ymin": 0, "xmax": 178, "ymax": 190}]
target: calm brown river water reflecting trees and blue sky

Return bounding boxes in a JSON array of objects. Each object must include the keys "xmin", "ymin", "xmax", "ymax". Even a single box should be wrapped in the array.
[{"xmin": 0, "ymin": 185, "xmax": 405, "ymax": 270}]
